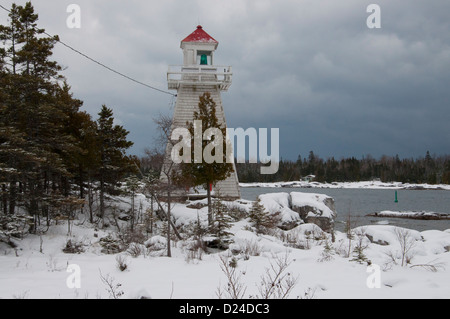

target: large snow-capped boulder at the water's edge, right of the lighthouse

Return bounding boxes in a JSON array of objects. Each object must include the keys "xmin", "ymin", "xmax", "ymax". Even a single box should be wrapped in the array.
[{"xmin": 290, "ymin": 192, "xmax": 336, "ymax": 233}]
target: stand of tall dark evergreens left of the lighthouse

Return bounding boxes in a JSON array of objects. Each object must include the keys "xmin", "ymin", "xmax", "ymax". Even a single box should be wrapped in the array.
[{"xmin": 0, "ymin": 2, "xmax": 138, "ymax": 226}]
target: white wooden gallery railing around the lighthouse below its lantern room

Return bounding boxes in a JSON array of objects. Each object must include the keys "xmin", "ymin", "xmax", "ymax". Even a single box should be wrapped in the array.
[{"xmin": 167, "ymin": 65, "xmax": 233, "ymax": 91}]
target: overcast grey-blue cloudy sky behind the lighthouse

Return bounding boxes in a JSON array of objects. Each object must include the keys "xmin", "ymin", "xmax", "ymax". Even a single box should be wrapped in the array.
[{"xmin": 0, "ymin": 0, "xmax": 450, "ymax": 160}]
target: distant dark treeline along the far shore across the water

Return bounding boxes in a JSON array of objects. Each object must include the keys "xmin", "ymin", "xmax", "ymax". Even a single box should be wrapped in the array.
[{"xmin": 236, "ymin": 151, "xmax": 450, "ymax": 184}]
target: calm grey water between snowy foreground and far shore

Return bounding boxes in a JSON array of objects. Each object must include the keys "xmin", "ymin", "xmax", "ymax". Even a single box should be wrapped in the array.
[{"xmin": 241, "ymin": 187, "xmax": 450, "ymax": 231}]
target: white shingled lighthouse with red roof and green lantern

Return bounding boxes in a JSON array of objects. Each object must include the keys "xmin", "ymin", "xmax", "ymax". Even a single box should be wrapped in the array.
[{"xmin": 161, "ymin": 25, "xmax": 241, "ymax": 200}]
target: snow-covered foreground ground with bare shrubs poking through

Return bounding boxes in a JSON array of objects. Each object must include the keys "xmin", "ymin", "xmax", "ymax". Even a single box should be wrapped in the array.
[{"xmin": 0, "ymin": 194, "xmax": 450, "ymax": 299}]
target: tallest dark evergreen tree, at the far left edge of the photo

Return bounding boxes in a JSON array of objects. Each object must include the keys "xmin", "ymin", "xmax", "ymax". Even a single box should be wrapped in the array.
[{"xmin": 0, "ymin": 2, "xmax": 68, "ymax": 224}]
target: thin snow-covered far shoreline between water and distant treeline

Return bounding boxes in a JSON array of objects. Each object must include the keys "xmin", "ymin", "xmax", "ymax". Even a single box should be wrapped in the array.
[{"xmin": 239, "ymin": 181, "xmax": 450, "ymax": 190}]
